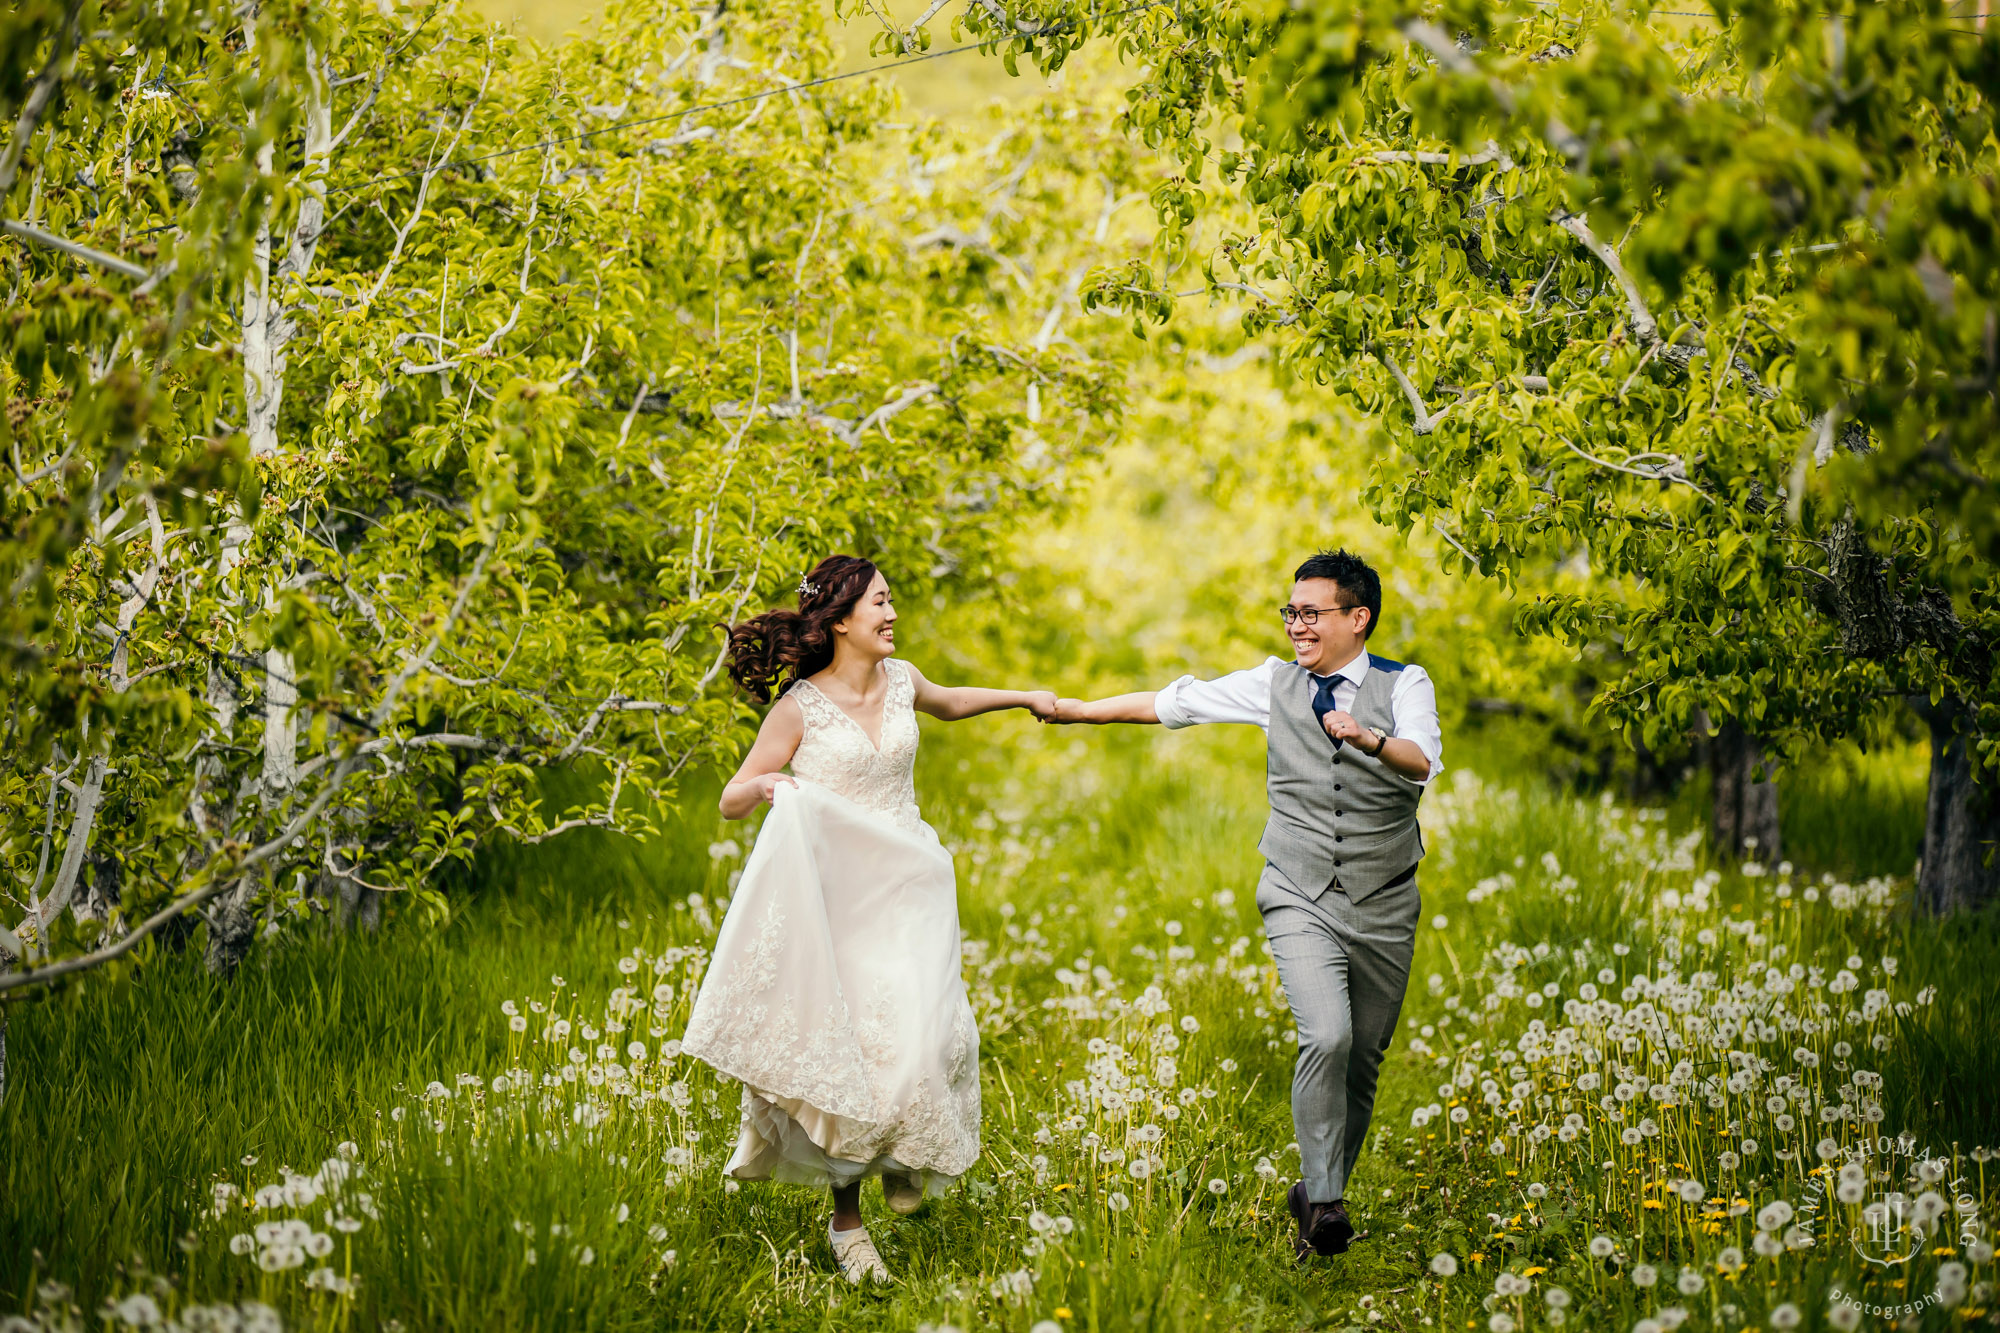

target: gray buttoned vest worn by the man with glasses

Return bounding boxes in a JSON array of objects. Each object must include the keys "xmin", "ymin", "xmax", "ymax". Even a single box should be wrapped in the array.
[{"xmin": 1258, "ymin": 654, "xmax": 1424, "ymax": 903}]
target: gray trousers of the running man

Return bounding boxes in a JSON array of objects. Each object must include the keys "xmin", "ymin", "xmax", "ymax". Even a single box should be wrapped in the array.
[{"xmin": 1256, "ymin": 865, "xmax": 1418, "ymax": 1203}]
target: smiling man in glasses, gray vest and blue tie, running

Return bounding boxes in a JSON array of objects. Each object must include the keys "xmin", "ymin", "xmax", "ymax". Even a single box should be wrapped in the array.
[{"xmin": 1050, "ymin": 550, "xmax": 1444, "ymax": 1261}]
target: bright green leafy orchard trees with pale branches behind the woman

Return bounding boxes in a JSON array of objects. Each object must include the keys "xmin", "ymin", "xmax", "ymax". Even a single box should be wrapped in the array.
[{"xmin": 0, "ymin": 0, "xmax": 1144, "ymax": 1088}]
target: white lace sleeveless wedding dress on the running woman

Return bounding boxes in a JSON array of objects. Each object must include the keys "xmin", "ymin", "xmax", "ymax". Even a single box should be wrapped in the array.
[{"xmin": 682, "ymin": 658, "xmax": 980, "ymax": 1193}]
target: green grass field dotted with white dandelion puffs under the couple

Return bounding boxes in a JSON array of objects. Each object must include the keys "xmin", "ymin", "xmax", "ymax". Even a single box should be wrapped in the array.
[{"xmin": 0, "ymin": 719, "xmax": 2000, "ymax": 1333}]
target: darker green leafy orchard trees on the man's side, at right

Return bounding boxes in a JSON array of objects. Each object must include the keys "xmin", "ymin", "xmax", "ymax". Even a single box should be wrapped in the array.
[{"xmin": 960, "ymin": 0, "xmax": 2000, "ymax": 911}]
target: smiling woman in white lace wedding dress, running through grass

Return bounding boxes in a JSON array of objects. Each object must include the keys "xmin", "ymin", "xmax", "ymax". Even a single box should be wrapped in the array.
[{"xmin": 684, "ymin": 556, "xmax": 1056, "ymax": 1283}]
